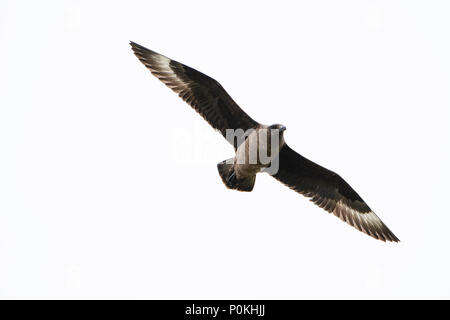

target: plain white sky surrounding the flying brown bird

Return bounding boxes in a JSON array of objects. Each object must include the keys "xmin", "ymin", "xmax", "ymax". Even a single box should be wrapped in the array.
[{"xmin": 0, "ymin": 0, "xmax": 450, "ymax": 299}]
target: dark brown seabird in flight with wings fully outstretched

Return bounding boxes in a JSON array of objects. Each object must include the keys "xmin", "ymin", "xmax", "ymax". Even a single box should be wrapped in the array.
[{"xmin": 130, "ymin": 42, "xmax": 399, "ymax": 242}]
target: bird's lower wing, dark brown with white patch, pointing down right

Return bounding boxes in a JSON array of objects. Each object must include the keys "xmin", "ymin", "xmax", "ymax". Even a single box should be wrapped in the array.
[{"xmin": 273, "ymin": 145, "xmax": 399, "ymax": 242}]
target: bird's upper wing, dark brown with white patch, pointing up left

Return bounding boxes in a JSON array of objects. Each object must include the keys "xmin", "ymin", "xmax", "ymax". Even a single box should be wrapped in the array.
[{"xmin": 130, "ymin": 42, "xmax": 258, "ymax": 145}]
